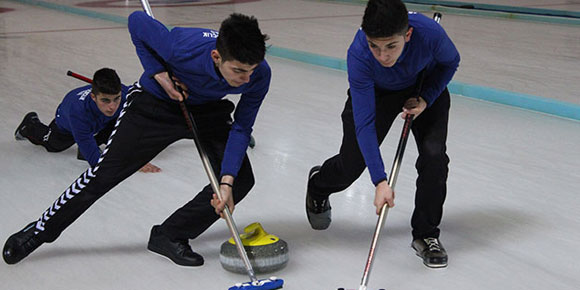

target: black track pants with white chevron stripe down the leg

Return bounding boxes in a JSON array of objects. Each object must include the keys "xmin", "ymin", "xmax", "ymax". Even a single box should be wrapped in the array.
[{"xmin": 31, "ymin": 86, "xmax": 254, "ymax": 242}]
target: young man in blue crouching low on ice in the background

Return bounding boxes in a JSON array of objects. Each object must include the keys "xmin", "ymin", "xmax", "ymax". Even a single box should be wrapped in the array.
[{"xmin": 14, "ymin": 68, "xmax": 160, "ymax": 172}]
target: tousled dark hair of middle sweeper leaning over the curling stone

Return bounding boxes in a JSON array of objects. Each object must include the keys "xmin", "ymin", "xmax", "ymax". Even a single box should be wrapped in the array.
[{"xmin": 216, "ymin": 13, "xmax": 268, "ymax": 65}]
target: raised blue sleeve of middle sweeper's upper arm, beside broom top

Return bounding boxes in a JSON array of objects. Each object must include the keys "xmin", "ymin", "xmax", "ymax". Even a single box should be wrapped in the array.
[{"xmin": 128, "ymin": 11, "xmax": 173, "ymax": 76}]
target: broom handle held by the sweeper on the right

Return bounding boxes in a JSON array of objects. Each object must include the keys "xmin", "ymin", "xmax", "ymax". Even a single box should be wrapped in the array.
[{"xmin": 359, "ymin": 12, "xmax": 441, "ymax": 290}]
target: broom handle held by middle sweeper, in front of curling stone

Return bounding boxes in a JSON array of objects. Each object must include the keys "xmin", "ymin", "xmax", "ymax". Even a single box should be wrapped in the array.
[{"xmin": 140, "ymin": 0, "xmax": 258, "ymax": 282}]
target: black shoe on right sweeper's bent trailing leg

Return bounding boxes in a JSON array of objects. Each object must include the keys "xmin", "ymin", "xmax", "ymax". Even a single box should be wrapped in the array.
[{"xmin": 306, "ymin": 166, "xmax": 332, "ymax": 230}]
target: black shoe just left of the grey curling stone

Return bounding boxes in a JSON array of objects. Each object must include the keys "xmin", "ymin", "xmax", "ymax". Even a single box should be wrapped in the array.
[{"xmin": 147, "ymin": 225, "xmax": 203, "ymax": 267}]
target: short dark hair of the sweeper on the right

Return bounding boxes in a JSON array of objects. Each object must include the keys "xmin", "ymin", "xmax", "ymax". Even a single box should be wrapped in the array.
[{"xmin": 361, "ymin": 0, "xmax": 409, "ymax": 38}]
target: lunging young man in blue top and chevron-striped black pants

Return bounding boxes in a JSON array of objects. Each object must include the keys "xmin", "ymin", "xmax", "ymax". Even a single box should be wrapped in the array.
[{"xmin": 3, "ymin": 12, "xmax": 271, "ymax": 266}]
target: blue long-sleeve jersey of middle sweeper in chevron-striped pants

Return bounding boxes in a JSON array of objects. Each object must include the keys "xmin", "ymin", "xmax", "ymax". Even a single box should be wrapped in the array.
[{"xmin": 129, "ymin": 11, "xmax": 271, "ymax": 177}]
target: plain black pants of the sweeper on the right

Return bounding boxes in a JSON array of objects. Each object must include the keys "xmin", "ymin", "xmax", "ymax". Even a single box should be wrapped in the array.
[{"xmin": 309, "ymin": 87, "xmax": 450, "ymax": 239}]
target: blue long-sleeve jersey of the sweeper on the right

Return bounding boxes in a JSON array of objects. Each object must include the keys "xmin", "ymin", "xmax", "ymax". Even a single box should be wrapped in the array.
[{"xmin": 347, "ymin": 12, "xmax": 459, "ymax": 185}]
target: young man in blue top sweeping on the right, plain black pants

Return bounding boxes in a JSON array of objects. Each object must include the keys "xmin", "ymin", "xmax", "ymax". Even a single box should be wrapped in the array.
[{"xmin": 306, "ymin": 0, "xmax": 459, "ymax": 267}]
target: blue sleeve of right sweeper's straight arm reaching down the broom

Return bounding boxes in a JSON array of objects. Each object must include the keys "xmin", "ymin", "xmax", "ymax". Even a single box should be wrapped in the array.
[{"xmin": 347, "ymin": 51, "xmax": 387, "ymax": 185}]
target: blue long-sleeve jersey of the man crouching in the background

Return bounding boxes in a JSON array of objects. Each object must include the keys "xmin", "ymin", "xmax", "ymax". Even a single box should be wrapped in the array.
[{"xmin": 54, "ymin": 85, "xmax": 129, "ymax": 167}]
